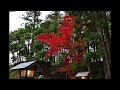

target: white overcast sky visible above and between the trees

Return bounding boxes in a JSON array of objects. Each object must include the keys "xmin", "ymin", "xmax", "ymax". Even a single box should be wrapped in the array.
[{"xmin": 9, "ymin": 11, "xmax": 63, "ymax": 63}]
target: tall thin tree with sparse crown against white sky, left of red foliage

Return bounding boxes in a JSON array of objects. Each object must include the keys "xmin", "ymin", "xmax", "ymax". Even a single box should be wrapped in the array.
[{"xmin": 22, "ymin": 11, "xmax": 42, "ymax": 58}]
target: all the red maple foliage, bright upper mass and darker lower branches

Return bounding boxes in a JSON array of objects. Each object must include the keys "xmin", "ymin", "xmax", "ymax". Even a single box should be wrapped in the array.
[{"xmin": 37, "ymin": 16, "xmax": 83, "ymax": 78}]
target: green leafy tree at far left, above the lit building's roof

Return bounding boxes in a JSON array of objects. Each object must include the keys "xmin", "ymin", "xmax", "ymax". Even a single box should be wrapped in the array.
[{"xmin": 9, "ymin": 28, "xmax": 27, "ymax": 63}]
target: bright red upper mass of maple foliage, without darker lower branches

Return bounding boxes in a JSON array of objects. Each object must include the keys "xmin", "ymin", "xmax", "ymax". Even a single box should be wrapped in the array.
[{"xmin": 38, "ymin": 16, "xmax": 74, "ymax": 56}]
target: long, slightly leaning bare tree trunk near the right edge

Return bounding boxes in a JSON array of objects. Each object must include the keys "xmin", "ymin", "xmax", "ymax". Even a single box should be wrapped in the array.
[{"xmin": 94, "ymin": 12, "xmax": 111, "ymax": 79}]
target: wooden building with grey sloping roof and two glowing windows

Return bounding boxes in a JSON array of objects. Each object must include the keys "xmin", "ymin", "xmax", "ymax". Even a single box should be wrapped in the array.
[{"xmin": 10, "ymin": 60, "xmax": 50, "ymax": 79}]
